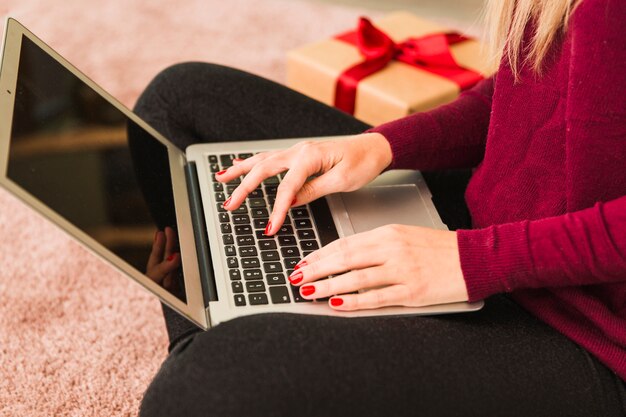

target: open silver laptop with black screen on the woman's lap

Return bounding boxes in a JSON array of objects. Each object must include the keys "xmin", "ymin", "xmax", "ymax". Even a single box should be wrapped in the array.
[{"xmin": 0, "ymin": 19, "xmax": 483, "ymax": 329}]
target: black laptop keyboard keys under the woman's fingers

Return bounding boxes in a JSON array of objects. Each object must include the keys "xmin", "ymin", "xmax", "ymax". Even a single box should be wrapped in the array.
[{"xmin": 208, "ymin": 153, "xmax": 325, "ymax": 306}]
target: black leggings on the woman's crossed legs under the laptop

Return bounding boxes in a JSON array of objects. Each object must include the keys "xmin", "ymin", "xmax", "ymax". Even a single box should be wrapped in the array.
[{"xmin": 136, "ymin": 63, "xmax": 625, "ymax": 417}]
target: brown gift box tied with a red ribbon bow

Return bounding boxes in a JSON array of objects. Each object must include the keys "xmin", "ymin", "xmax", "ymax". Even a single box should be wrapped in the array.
[{"xmin": 287, "ymin": 12, "xmax": 493, "ymax": 125}]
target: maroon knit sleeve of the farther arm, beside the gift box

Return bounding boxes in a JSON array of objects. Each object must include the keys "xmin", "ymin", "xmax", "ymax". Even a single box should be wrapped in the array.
[{"xmin": 368, "ymin": 77, "xmax": 494, "ymax": 170}]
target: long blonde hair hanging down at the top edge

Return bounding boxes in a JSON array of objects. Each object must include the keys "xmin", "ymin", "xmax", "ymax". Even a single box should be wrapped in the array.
[{"xmin": 485, "ymin": 0, "xmax": 581, "ymax": 79}]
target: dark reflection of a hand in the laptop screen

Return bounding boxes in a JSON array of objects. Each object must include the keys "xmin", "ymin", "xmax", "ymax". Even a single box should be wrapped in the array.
[{"xmin": 146, "ymin": 227, "xmax": 180, "ymax": 291}]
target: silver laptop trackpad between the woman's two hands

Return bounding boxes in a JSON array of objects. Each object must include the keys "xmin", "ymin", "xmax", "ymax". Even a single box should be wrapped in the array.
[{"xmin": 341, "ymin": 184, "xmax": 436, "ymax": 233}]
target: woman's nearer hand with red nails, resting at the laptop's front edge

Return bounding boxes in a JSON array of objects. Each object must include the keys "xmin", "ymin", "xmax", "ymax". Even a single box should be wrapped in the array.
[{"xmin": 289, "ymin": 224, "xmax": 468, "ymax": 311}]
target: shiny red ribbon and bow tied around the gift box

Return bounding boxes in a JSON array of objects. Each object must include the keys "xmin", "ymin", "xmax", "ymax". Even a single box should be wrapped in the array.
[{"xmin": 335, "ymin": 17, "xmax": 483, "ymax": 114}]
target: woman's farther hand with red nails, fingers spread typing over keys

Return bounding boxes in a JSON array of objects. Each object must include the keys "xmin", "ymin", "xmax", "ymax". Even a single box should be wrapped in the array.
[{"xmin": 216, "ymin": 133, "xmax": 392, "ymax": 235}]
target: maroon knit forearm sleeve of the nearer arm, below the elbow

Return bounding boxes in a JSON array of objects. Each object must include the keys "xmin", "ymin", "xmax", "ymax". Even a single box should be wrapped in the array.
[{"xmin": 457, "ymin": 196, "xmax": 626, "ymax": 301}]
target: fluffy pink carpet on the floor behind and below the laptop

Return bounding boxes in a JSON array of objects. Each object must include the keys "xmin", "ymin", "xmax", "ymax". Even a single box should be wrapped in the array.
[{"xmin": 0, "ymin": 0, "xmax": 378, "ymax": 416}]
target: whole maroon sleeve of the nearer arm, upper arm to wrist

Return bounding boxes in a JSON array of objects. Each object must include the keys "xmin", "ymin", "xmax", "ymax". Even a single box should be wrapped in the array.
[{"xmin": 457, "ymin": 0, "xmax": 626, "ymax": 300}]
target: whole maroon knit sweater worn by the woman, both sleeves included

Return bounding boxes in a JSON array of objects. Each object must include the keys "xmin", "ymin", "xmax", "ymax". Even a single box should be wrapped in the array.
[{"xmin": 372, "ymin": 0, "xmax": 626, "ymax": 379}]
